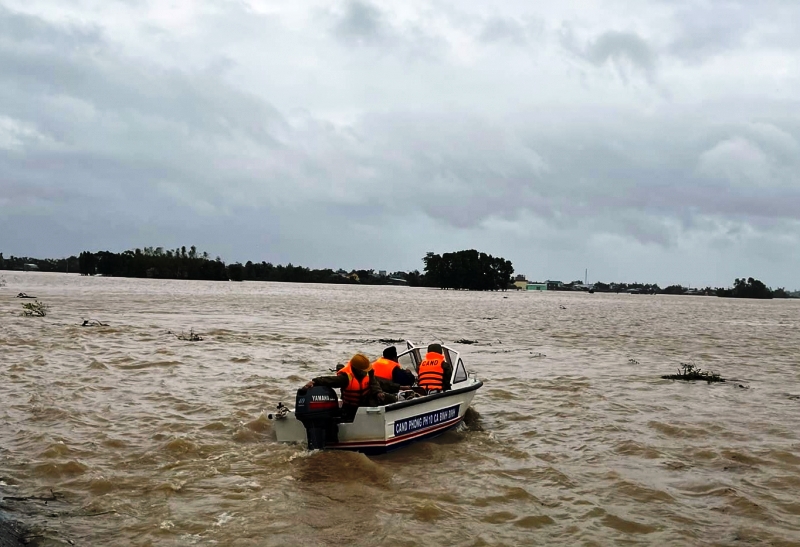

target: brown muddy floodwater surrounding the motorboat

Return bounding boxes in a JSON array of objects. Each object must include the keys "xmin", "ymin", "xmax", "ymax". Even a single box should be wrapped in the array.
[{"xmin": 0, "ymin": 272, "xmax": 800, "ymax": 547}]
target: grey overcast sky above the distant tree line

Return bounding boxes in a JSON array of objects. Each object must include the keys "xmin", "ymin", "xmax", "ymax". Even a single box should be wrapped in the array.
[{"xmin": 0, "ymin": 0, "xmax": 800, "ymax": 289}]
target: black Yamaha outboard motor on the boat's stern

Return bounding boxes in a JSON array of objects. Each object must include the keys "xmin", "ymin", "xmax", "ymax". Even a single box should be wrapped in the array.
[{"xmin": 294, "ymin": 386, "xmax": 342, "ymax": 450}]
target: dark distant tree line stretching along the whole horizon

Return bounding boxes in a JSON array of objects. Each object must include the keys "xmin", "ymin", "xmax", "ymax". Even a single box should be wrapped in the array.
[{"xmin": 0, "ymin": 245, "xmax": 788, "ymax": 299}]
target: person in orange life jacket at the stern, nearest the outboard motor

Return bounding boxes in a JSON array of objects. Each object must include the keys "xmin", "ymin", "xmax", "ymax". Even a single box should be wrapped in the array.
[{"xmin": 303, "ymin": 353, "xmax": 397, "ymax": 413}]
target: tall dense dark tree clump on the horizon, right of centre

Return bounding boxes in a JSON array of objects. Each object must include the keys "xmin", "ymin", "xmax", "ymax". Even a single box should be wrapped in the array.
[{"xmin": 422, "ymin": 249, "xmax": 514, "ymax": 291}]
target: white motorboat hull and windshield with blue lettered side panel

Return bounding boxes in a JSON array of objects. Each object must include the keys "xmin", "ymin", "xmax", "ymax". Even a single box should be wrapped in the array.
[{"xmin": 269, "ymin": 341, "xmax": 483, "ymax": 454}]
